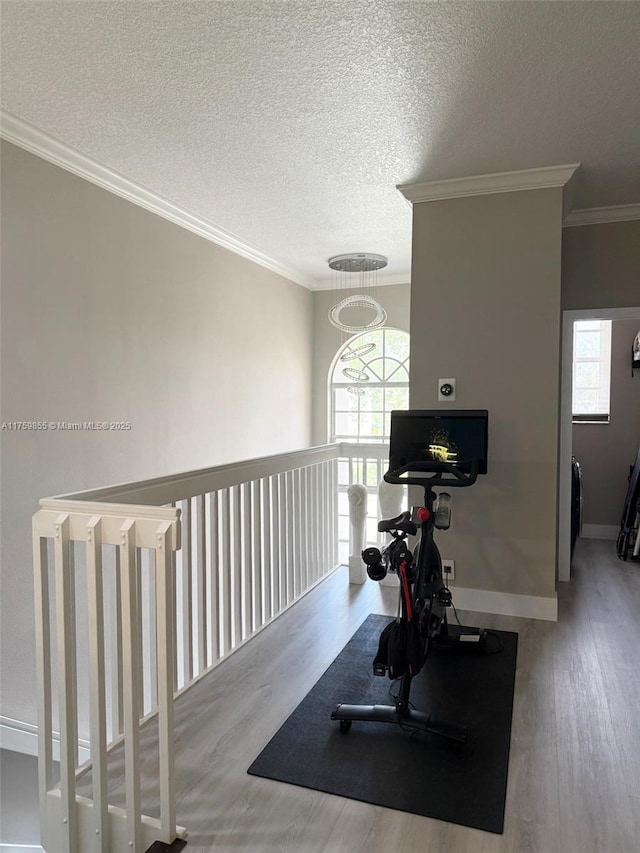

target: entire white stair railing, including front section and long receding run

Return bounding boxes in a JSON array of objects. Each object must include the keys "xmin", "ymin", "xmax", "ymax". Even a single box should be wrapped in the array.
[{"xmin": 33, "ymin": 445, "xmax": 340, "ymax": 853}]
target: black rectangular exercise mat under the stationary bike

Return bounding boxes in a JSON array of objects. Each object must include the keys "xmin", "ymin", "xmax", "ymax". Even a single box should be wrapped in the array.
[{"xmin": 248, "ymin": 615, "xmax": 518, "ymax": 833}]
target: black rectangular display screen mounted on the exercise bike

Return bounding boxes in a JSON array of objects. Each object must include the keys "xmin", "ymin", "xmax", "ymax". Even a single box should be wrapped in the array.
[{"xmin": 389, "ymin": 409, "xmax": 488, "ymax": 474}]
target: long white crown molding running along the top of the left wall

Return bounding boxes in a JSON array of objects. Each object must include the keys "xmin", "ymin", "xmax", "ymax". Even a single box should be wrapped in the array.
[{"xmin": 0, "ymin": 110, "xmax": 316, "ymax": 290}]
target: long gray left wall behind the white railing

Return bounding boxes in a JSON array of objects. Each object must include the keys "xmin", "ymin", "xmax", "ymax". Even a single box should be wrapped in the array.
[{"xmin": 0, "ymin": 143, "xmax": 313, "ymax": 723}]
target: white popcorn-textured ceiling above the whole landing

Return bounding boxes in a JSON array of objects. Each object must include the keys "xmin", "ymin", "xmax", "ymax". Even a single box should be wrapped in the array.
[{"xmin": 0, "ymin": 0, "xmax": 640, "ymax": 286}]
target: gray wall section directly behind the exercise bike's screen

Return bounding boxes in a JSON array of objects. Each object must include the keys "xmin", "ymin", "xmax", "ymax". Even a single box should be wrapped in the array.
[{"xmin": 411, "ymin": 189, "xmax": 562, "ymax": 597}]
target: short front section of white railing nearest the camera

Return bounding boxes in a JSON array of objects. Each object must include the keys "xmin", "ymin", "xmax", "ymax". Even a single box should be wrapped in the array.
[{"xmin": 33, "ymin": 500, "xmax": 184, "ymax": 853}]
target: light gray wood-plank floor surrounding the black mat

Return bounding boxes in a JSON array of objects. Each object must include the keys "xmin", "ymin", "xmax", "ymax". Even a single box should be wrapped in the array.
[{"xmin": 87, "ymin": 540, "xmax": 640, "ymax": 853}]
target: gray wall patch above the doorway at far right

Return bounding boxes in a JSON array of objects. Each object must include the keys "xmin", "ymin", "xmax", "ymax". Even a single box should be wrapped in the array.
[{"xmin": 562, "ymin": 220, "xmax": 640, "ymax": 311}]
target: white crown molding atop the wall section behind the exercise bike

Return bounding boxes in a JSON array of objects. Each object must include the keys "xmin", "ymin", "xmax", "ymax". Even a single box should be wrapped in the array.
[{"xmin": 397, "ymin": 163, "xmax": 580, "ymax": 204}]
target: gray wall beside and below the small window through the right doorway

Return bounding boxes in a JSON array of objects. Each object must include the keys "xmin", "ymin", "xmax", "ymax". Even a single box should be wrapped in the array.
[{"xmin": 573, "ymin": 320, "xmax": 640, "ymax": 526}]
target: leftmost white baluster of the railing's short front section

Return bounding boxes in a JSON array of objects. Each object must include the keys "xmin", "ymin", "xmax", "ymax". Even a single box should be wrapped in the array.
[{"xmin": 33, "ymin": 518, "xmax": 53, "ymax": 840}]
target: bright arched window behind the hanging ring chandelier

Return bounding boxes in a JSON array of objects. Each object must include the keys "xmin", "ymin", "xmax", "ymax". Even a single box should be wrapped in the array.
[{"xmin": 330, "ymin": 328, "xmax": 409, "ymax": 443}]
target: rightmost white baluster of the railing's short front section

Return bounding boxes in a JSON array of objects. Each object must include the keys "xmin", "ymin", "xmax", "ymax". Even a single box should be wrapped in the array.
[{"xmin": 155, "ymin": 522, "xmax": 176, "ymax": 850}]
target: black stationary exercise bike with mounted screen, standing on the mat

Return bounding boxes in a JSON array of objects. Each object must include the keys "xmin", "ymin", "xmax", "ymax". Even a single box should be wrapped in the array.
[{"xmin": 331, "ymin": 411, "xmax": 487, "ymax": 744}]
